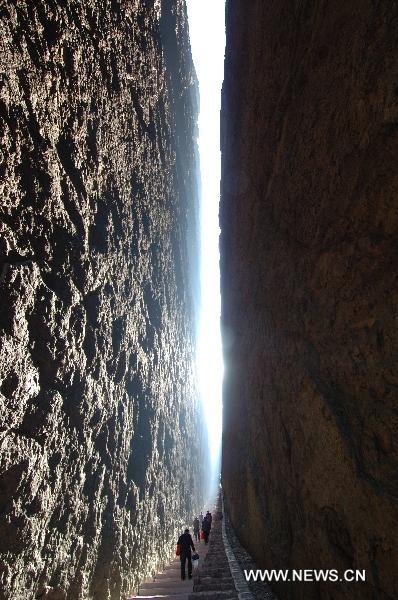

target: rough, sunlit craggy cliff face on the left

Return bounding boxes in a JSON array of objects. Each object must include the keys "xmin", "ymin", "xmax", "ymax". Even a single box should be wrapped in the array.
[{"xmin": 0, "ymin": 0, "xmax": 203, "ymax": 600}]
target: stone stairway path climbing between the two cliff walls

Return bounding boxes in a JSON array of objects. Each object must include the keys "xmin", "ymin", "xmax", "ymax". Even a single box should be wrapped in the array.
[{"xmin": 130, "ymin": 497, "xmax": 244, "ymax": 600}]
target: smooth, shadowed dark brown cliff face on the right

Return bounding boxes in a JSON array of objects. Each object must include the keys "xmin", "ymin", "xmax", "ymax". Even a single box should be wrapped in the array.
[{"xmin": 221, "ymin": 0, "xmax": 398, "ymax": 600}]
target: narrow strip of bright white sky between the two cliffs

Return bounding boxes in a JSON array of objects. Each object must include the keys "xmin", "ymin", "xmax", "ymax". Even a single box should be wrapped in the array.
[{"xmin": 187, "ymin": 0, "xmax": 225, "ymax": 467}]
